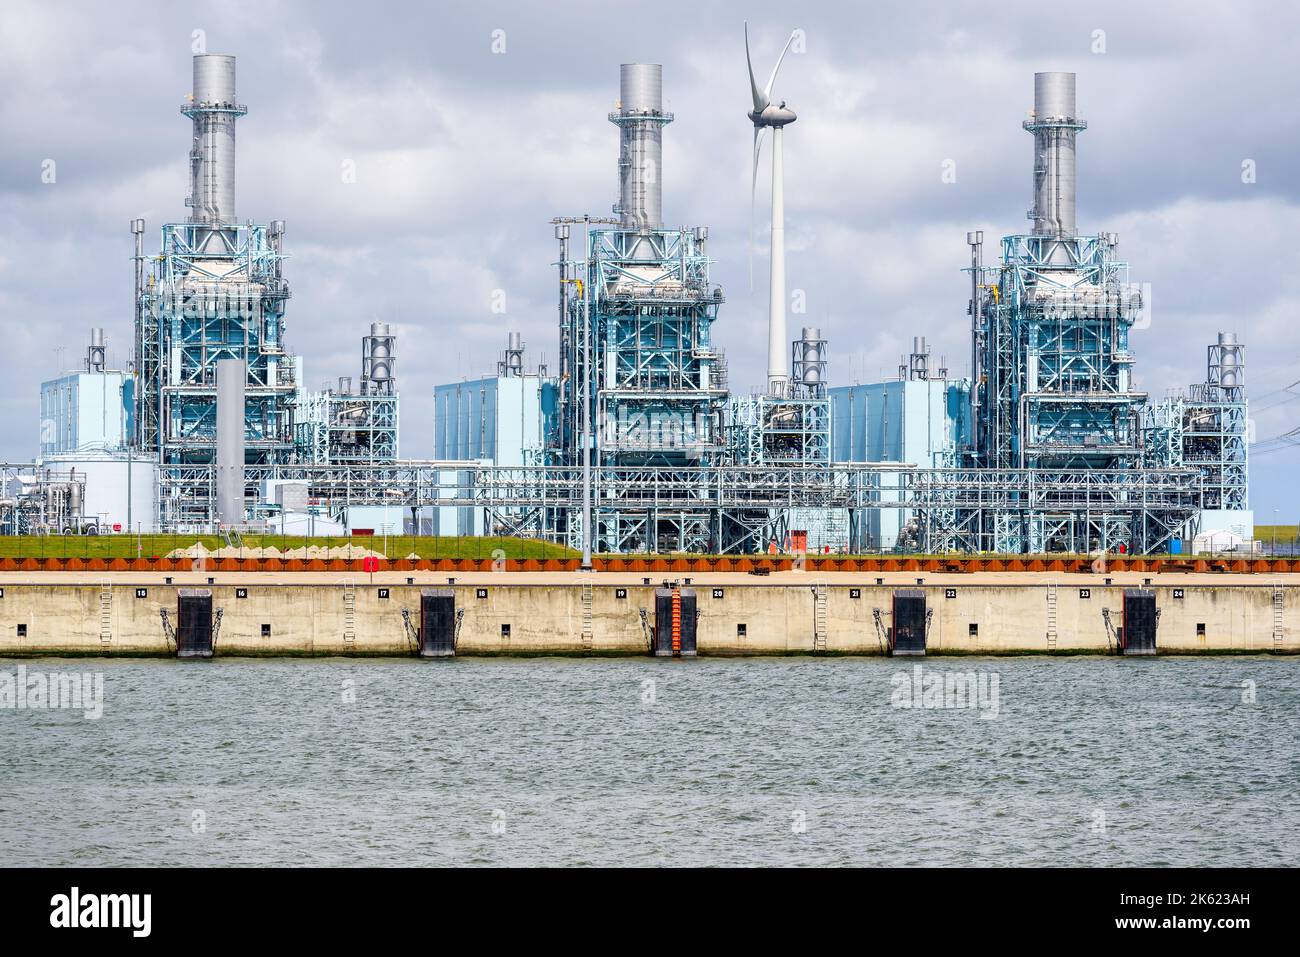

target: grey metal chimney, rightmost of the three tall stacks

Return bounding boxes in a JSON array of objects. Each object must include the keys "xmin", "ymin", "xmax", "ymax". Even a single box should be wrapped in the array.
[{"xmin": 1024, "ymin": 73, "xmax": 1088, "ymax": 250}]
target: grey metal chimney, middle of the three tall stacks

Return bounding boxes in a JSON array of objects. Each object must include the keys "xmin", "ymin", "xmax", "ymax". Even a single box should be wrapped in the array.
[{"xmin": 610, "ymin": 64, "xmax": 672, "ymax": 259}]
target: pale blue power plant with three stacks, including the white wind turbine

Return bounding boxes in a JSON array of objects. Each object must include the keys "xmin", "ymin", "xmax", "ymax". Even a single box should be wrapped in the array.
[{"xmin": 0, "ymin": 39, "xmax": 1253, "ymax": 559}]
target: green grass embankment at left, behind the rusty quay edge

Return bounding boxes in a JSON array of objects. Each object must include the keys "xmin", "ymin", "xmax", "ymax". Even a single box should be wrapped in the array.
[{"xmin": 0, "ymin": 534, "xmax": 577, "ymax": 558}]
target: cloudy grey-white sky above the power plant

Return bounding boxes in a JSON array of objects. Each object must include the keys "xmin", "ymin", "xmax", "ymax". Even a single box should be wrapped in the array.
[{"xmin": 0, "ymin": 0, "xmax": 1300, "ymax": 521}]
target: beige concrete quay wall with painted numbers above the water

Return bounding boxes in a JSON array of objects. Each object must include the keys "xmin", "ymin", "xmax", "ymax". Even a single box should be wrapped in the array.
[{"xmin": 0, "ymin": 575, "xmax": 1300, "ymax": 657}]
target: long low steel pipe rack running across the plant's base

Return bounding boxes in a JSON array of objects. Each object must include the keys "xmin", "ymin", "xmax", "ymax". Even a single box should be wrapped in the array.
[{"xmin": 147, "ymin": 460, "xmax": 1203, "ymax": 554}]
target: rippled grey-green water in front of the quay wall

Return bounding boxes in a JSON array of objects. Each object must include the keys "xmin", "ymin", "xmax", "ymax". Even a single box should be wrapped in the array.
[{"xmin": 0, "ymin": 658, "xmax": 1300, "ymax": 865}]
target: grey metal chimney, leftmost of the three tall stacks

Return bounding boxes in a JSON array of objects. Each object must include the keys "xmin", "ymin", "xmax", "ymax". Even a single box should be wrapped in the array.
[{"xmin": 181, "ymin": 53, "xmax": 248, "ymax": 226}]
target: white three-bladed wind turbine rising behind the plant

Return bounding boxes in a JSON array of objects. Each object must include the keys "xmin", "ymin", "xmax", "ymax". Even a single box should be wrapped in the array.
[{"xmin": 745, "ymin": 21, "xmax": 797, "ymax": 395}]
